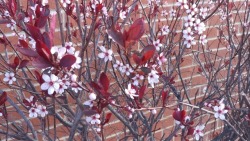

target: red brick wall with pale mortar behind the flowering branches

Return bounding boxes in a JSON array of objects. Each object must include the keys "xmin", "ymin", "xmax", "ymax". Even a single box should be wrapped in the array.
[{"xmin": 0, "ymin": 0, "xmax": 246, "ymax": 141}]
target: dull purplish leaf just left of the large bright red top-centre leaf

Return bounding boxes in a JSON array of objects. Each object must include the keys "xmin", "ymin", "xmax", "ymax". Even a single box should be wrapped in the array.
[{"xmin": 108, "ymin": 27, "xmax": 125, "ymax": 47}]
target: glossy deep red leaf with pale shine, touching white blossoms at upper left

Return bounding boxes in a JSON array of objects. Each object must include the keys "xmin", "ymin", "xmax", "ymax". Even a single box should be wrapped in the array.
[{"xmin": 36, "ymin": 40, "xmax": 52, "ymax": 61}]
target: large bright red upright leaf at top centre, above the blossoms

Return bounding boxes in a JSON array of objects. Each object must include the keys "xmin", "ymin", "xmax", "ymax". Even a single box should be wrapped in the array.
[{"xmin": 127, "ymin": 18, "xmax": 145, "ymax": 41}]
